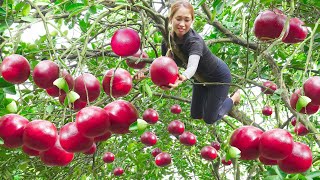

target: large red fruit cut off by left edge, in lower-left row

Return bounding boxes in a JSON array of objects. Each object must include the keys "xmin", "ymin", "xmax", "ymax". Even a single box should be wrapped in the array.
[{"xmin": 0, "ymin": 114, "xmax": 29, "ymax": 148}]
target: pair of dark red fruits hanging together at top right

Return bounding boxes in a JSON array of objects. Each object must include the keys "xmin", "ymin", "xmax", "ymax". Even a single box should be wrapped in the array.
[{"xmin": 253, "ymin": 9, "xmax": 308, "ymax": 43}]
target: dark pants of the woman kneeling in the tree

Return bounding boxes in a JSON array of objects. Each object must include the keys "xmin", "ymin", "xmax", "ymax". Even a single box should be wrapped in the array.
[{"xmin": 191, "ymin": 60, "xmax": 233, "ymax": 124}]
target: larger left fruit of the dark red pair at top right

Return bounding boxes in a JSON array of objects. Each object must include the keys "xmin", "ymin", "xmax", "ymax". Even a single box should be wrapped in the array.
[{"xmin": 253, "ymin": 9, "xmax": 288, "ymax": 41}]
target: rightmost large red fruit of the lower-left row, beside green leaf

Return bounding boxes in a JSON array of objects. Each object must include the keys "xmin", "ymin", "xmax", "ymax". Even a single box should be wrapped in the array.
[{"xmin": 104, "ymin": 100, "xmax": 138, "ymax": 134}]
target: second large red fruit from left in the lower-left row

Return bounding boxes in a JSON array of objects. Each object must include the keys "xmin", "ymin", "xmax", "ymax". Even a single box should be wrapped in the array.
[{"xmin": 23, "ymin": 120, "xmax": 58, "ymax": 151}]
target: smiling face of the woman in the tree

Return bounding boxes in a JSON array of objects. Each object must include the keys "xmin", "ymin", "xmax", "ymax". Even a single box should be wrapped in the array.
[{"xmin": 171, "ymin": 6, "xmax": 193, "ymax": 38}]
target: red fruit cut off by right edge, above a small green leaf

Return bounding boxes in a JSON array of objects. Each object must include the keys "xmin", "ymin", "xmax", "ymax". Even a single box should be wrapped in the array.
[{"xmin": 303, "ymin": 76, "xmax": 320, "ymax": 105}]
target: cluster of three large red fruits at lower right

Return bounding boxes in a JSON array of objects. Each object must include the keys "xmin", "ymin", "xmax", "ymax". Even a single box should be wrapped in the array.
[{"xmin": 229, "ymin": 126, "xmax": 312, "ymax": 174}]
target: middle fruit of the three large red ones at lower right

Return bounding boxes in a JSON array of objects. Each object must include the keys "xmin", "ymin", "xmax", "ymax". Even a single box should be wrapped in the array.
[{"xmin": 259, "ymin": 129, "xmax": 293, "ymax": 160}]
